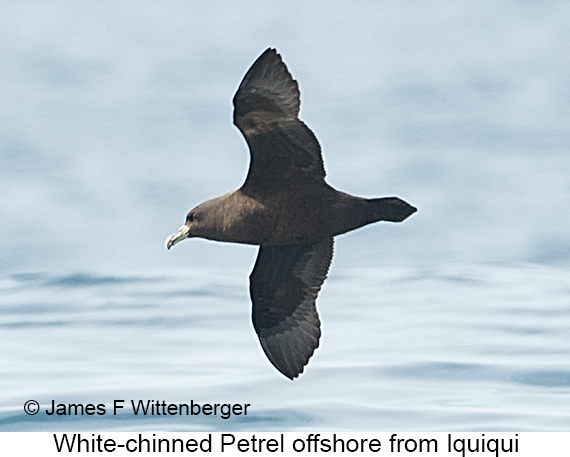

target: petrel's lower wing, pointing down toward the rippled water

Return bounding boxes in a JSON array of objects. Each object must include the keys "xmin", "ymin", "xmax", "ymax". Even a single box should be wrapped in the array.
[{"xmin": 249, "ymin": 238, "xmax": 333, "ymax": 379}]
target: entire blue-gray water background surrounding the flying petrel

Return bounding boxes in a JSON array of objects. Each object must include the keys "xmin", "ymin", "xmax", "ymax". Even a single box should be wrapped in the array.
[{"xmin": 0, "ymin": 0, "xmax": 570, "ymax": 431}]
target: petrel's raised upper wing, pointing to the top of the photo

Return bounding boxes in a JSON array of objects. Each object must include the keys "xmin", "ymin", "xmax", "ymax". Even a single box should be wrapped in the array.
[{"xmin": 234, "ymin": 49, "xmax": 325, "ymax": 193}]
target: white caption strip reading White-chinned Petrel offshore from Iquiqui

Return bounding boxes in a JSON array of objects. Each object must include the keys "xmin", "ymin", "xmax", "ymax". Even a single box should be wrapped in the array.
[{"xmin": 0, "ymin": 432, "xmax": 570, "ymax": 457}]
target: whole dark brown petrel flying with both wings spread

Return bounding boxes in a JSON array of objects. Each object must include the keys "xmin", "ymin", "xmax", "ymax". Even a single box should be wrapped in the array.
[{"xmin": 166, "ymin": 49, "xmax": 416, "ymax": 379}]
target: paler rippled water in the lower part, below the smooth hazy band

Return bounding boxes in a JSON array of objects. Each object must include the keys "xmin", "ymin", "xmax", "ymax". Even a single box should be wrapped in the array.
[{"xmin": 0, "ymin": 262, "xmax": 570, "ymax": 431}]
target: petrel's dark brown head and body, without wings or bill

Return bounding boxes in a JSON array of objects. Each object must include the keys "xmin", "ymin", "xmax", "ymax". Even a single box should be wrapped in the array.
[{"xmin": 180, "ymin": 184, "xmax": 407, "ymax": 246}]
